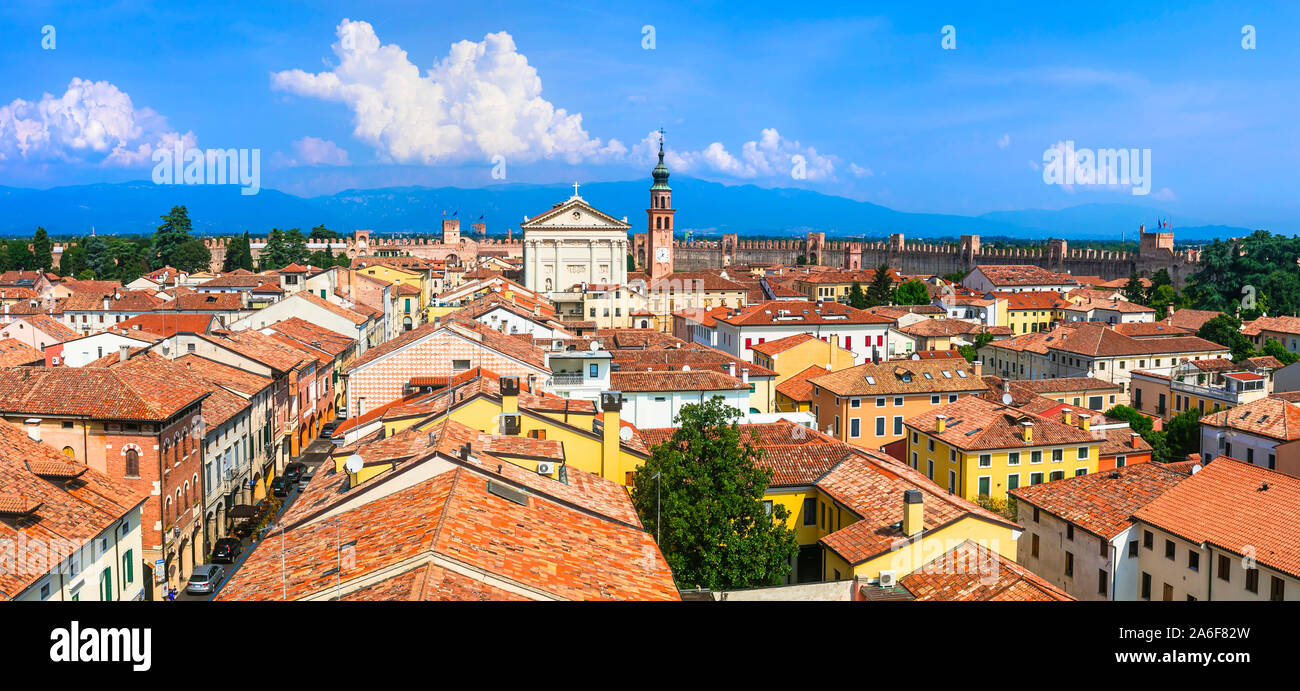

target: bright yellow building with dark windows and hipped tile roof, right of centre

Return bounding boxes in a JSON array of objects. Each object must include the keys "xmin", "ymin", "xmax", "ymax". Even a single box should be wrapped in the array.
[{"xmin": 904, "ymin": 396, "xmax": 1105, "ymax": 501}]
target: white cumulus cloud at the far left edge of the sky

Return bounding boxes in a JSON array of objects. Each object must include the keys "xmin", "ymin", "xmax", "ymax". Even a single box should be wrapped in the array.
[{"xmin": 0, "ymin": 78, "xmax": 195, "ymax": 166}]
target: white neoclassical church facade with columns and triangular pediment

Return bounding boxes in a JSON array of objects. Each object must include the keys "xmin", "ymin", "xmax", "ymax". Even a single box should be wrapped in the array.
[{"xmin": 520, "ymin": 190, "xmax": 632, "ymax": 292}]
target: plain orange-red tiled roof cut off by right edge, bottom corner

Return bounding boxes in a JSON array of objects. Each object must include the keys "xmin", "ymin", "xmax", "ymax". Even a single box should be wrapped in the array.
[{"xmin": 1134, "ymin": 456, "xmax": 1300, "ymax": 577}]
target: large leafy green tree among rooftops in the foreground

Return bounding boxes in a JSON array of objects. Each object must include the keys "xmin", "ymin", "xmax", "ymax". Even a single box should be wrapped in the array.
[{"xmin": 632, "ymin": 399, "xmax": 798, "ymax": 590}]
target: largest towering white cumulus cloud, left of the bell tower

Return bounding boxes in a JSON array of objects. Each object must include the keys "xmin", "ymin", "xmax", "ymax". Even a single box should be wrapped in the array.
[{"xmin": 270, "ymin": 19, "xmax": 627, "ymax": 164}]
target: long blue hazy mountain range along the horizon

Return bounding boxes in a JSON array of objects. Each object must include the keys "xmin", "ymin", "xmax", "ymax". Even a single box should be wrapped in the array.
[{"xmin": 0, "ymin": 175, "xmax": 1248, "ymax": 240}]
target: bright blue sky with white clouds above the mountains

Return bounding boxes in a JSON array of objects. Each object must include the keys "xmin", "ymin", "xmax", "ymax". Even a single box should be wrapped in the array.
[{"xmin": 0, "ymin": 0, "xmax": 1300, "ymax": 227}]
